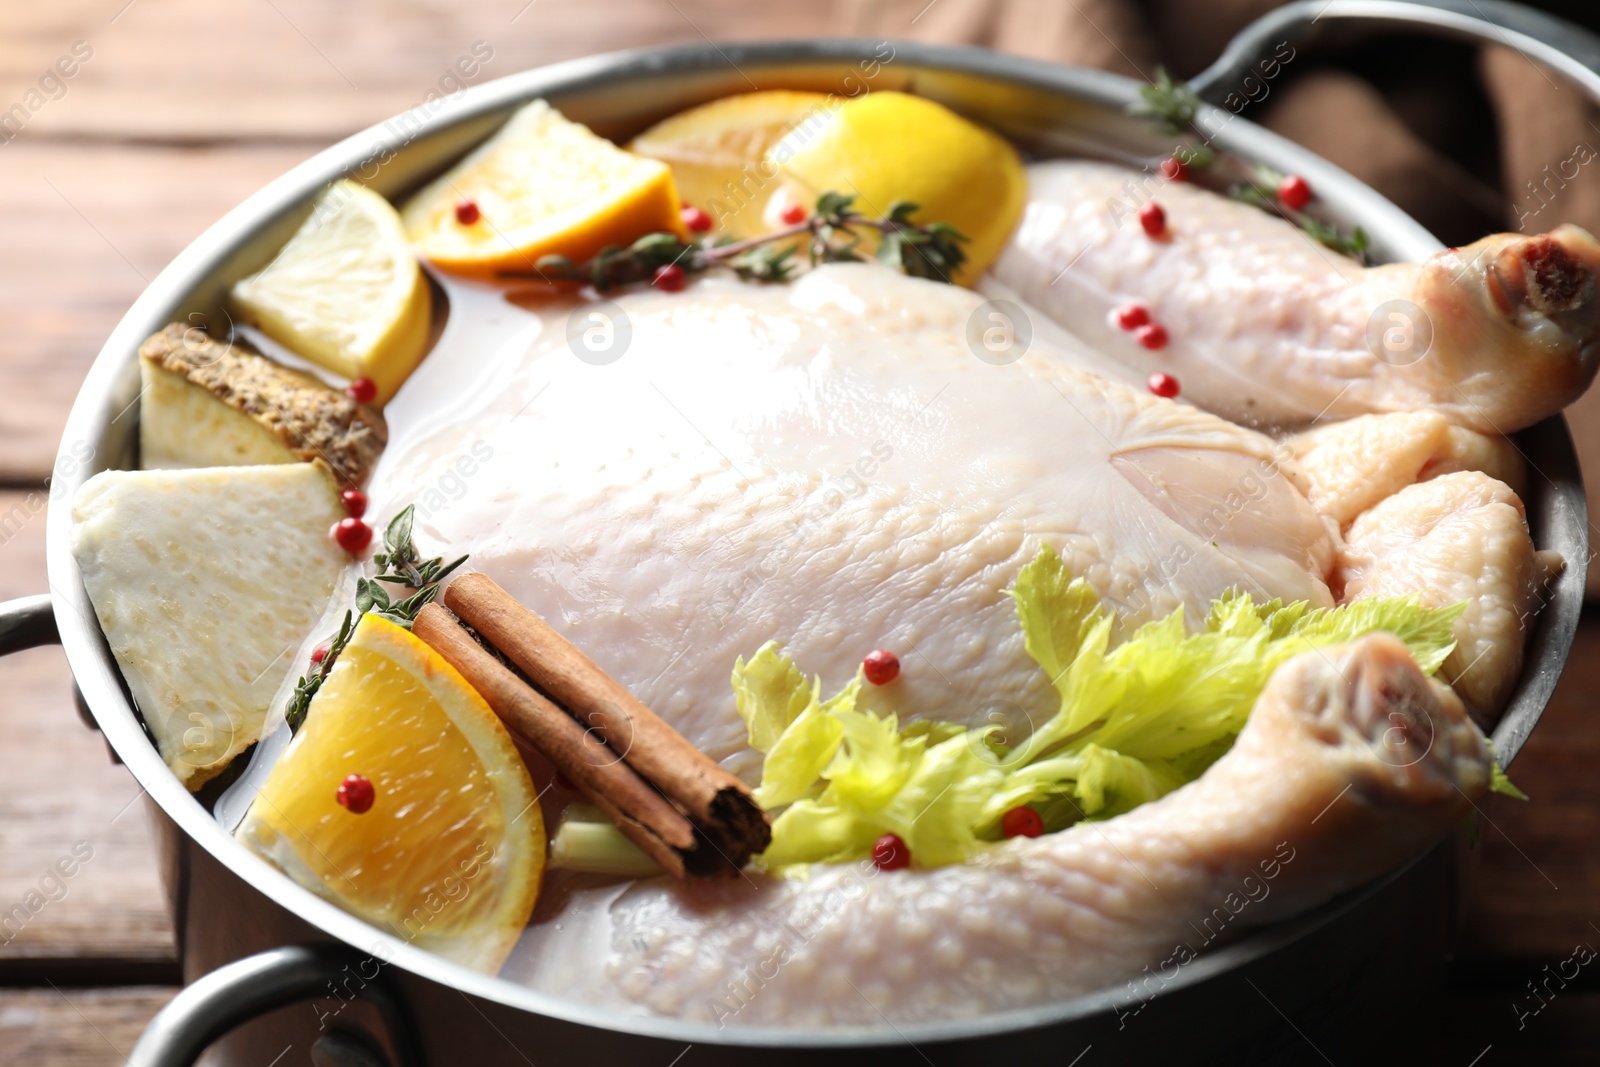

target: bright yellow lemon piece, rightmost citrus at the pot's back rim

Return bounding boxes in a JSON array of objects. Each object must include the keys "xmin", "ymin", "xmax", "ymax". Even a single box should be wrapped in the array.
[{"xmin": 766, "ymin": 90, "xmax": 1027, "ymax": 285}]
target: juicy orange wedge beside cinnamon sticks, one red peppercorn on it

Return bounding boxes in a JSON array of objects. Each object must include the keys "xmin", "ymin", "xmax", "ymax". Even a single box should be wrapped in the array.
[{"xmin": 238, "ymin": 614, "xmax": 546, "ymax": 974}]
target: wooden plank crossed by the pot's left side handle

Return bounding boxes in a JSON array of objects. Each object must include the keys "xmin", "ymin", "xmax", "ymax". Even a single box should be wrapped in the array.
[{"xmin": 0, "ymin": 491, "xmax": 173, "ymax": 972}]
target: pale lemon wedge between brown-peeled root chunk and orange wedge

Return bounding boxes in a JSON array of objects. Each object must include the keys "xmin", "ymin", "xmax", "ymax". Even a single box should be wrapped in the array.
[{"xmin": 232, "ymin": 181, "xmax": 434, "ymax": 403}]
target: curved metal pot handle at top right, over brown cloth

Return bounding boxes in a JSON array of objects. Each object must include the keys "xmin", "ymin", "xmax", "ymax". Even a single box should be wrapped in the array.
[{"xmin": 1189, "ymin": 0, "xmax": 1600, "ymax": 112}]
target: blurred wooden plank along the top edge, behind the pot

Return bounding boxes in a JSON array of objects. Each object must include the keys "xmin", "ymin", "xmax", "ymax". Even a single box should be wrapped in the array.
[{"xmin": 0, "ymin": 0, "xmax": 851, "ymax": 141}]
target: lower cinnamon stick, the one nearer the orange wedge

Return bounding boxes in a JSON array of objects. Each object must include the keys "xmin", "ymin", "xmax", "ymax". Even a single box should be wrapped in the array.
[{"xmin": 411, "ymin": 603, "xmax": 709, "ymax": 878}]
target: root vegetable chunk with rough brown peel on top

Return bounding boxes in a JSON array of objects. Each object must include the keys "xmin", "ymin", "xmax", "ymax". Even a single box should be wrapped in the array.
[{"xmin": 139, "ymin": 323, "xmax": 389, "ymax": 486}]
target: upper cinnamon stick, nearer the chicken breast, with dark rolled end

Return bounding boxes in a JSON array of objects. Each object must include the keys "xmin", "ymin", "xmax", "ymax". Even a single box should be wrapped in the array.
[{"xmin": 445, "ymin": 574, "xmax": 773, "ymax": 867}]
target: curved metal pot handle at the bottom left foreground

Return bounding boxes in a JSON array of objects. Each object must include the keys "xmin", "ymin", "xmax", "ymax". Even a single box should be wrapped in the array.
[{"xmin": 126, "ymin": 945, "xmax": 418, "ymax": 1067}]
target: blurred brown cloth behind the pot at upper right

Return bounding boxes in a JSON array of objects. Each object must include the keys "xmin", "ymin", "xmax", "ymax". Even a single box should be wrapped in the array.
[{"xmin": 835, "ymin": 0, "xmax": 1600, "ymax": 595}]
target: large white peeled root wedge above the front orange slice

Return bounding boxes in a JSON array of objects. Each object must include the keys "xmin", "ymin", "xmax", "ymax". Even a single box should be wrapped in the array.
[{"xmin": 72, "ymin": 464, "xmax": 347, "ymax": 789}]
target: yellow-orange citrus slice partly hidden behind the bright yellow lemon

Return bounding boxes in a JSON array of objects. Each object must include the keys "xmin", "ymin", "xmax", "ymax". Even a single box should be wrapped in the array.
[{"xmin": 627, "ymin": 90, "xmax": 837, "ymax": 237}]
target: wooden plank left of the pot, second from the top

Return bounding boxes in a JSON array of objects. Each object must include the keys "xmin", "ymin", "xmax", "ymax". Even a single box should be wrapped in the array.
[{"xmin": 0, "ymin": 139, "xmax": 314, "ymax": 485}]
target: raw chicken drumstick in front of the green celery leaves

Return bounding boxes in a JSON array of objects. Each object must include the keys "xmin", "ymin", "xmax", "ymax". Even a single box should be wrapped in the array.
[{"xmin": 570, "ymin": 633, "xmax": 1491, "ymax": 1027}]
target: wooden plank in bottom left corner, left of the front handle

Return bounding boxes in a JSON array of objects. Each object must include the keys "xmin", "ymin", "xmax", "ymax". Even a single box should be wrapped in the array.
[{"xmin": 0, "ymin": 987, "xmax": 175, "ymax": 1067}]
